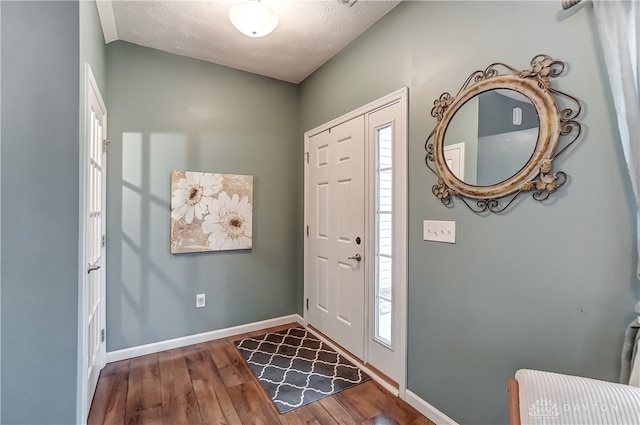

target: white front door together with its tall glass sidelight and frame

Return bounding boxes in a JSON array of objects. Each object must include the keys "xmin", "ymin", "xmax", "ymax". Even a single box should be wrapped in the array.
[{"xmin": 305, "ymin": 88, "xmax": 408, "ymax": 397}]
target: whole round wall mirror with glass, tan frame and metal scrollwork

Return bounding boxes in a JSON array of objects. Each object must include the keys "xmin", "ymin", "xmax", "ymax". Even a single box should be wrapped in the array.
[{"xmin": 425, "ymin": 55, "xmax": 582, "ymax": 214}]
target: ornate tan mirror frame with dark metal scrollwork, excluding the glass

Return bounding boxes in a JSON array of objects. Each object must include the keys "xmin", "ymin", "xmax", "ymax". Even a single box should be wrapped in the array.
[{"xmin": 425, "ymin": 54, "xmax": 582, "ymax": 214}]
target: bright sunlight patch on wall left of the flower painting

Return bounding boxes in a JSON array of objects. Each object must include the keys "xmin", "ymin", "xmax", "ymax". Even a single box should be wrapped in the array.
[{"xmin": 114, "ymin": 133, "xmax": 191, "ymax": 341}]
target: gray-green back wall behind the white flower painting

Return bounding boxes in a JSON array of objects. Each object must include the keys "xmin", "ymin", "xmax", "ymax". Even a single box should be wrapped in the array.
[{"xmin": 106, "ymin": 42, "xmax": 302, "ymax": 351}]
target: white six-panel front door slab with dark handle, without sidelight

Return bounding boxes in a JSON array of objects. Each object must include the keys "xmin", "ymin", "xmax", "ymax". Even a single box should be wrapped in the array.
[{"xmin": 307, "ymin": 116, "xmax": 367, "ymax": 359}]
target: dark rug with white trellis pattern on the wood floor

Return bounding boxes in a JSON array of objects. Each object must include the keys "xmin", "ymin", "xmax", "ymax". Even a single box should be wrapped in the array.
[{"xmin": 235, "ymin": 328, "xmax": 371, "ymax": 413}]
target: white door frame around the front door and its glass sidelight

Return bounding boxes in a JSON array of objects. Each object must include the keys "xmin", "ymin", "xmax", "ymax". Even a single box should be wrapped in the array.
[{"xmin": 303, "ymin": 87, "xmax": 409, "ymax": 399}]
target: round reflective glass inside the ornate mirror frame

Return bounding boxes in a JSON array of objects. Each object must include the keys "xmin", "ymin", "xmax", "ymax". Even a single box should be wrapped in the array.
[{"xmin": 443, "ymin": 89, "xmax": 538, "ymax": 186}]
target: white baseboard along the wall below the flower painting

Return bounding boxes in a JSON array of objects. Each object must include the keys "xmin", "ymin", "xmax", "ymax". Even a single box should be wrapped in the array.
[{"xmin": 106, "ymin": 314, "xmax": 304, "ymax": 363}]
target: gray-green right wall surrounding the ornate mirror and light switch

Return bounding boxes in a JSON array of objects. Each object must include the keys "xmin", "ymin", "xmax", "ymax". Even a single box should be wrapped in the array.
[{"xmin": 299, "ymin": 1, "xmax": 639, "ymax": 424}]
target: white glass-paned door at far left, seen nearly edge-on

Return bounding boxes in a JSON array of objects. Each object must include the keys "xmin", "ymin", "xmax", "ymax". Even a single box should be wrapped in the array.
[{"xmin": 79, "ymin": 65, "xmax": 107, "ymax": 422}]
